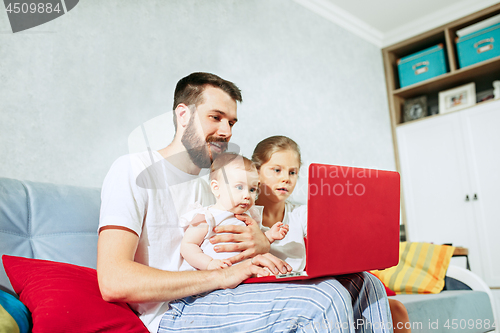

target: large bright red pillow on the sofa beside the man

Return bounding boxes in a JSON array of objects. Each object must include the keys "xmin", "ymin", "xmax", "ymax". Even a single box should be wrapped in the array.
[{"xmin": 2, "ymin": 255, "xmax": 148, "ymax": 333}]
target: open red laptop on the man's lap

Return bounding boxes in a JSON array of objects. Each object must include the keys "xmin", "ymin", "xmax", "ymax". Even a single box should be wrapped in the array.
[{"xmin": 244, "ymin": 164, "xmax": 400, "ymax": 283}]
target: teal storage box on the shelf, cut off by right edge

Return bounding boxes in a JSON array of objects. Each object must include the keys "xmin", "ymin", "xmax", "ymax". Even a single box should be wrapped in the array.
[{"xmin": 457, "ymin": 23, "xmax": 500, "ymax": 68}]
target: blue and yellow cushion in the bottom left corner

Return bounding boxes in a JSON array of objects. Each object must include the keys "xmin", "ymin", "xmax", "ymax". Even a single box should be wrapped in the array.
[{"xmin": 0, "ymin": 290, "xmax": 31, "ymax": 333}]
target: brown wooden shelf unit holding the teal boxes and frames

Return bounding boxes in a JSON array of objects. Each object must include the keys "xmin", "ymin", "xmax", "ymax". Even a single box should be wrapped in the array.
[{"xmin": 382, "ymin": 3, "xmax": 500, "ymax": 228}]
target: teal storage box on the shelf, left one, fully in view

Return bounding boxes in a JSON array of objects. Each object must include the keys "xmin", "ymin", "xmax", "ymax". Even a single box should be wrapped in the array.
[{"xmin": 398, "ymin": 44, "xmax": 446, "ymax": 88}]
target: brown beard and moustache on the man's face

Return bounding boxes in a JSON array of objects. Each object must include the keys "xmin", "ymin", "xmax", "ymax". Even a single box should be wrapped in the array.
[{"xmin": 181, "ymin": 116, "xmax": 228, "ymax": 169}]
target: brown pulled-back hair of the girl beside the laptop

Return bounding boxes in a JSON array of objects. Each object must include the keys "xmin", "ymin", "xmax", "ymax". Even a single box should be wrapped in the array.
[{"xmin": 252, "ymin": 135, "xmax": 302, "ymax": 170}]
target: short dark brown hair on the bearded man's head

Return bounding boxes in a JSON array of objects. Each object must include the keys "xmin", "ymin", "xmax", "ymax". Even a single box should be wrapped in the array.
[{"xmin": 173, "ymin": 72, "xmax": 242, "ymax": 130}]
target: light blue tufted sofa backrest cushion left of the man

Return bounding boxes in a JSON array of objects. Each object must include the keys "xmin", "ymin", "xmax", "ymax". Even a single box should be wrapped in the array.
[{"xmin": 0, "ymin": 178, "xmax": 100, "ymax": 291}]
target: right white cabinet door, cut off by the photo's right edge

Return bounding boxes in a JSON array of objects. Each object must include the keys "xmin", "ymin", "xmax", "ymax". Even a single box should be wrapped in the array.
[{"xmin": 461, "ymin": 101, "xmax": 500, "ymax": 287}]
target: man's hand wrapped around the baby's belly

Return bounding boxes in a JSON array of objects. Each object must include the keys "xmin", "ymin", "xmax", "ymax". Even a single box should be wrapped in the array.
[{"xmin": 210, "ymin": 215, "xmax": 271, "ymax": 264}]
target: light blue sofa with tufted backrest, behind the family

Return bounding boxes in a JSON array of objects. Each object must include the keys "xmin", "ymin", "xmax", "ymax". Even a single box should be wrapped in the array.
[{"xmin": 0, "ymin": 178, "xmax": 493, "ymax": 333}]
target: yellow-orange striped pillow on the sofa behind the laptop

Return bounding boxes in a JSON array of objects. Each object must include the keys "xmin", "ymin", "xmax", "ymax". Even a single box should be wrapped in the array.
[{"xmin": 372, "ymin": 242, "xmax": 455, "ymax": 294}]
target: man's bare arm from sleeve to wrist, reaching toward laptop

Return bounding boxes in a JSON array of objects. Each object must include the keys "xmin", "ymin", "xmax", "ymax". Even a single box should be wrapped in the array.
[{"xmin": 97, "ymin": 228, "xmax": 225, "ymax": 303}]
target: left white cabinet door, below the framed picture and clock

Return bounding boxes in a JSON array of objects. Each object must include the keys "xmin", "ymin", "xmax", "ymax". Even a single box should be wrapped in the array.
[{"xmin": 396, "ymin": 113, "xmax": 482, "ymax": 276}]
